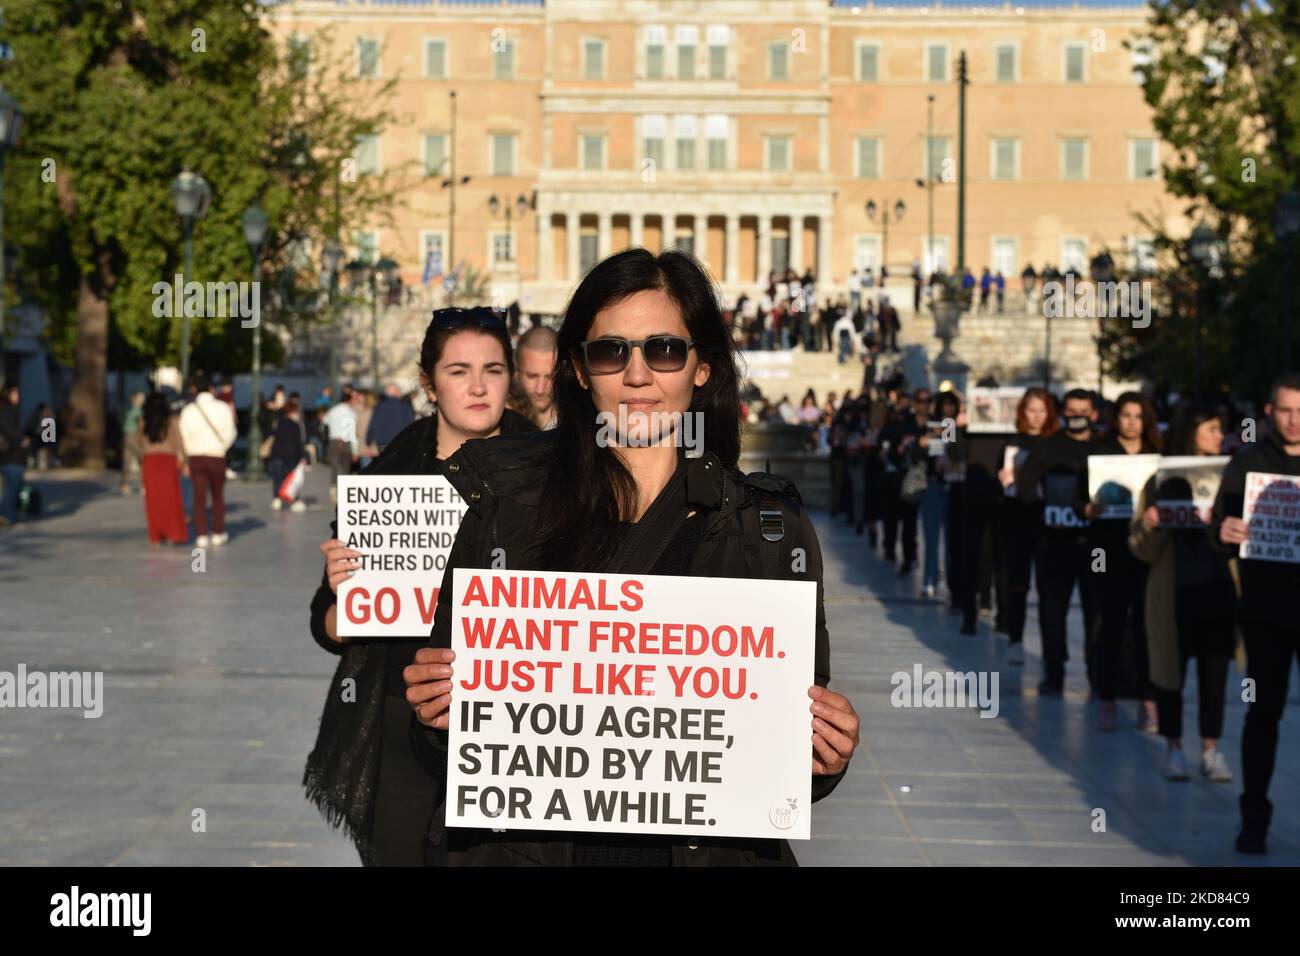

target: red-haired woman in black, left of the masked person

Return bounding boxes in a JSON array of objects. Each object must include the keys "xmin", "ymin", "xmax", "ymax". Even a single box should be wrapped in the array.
[{"xmin": 996, "ymin": 388, "xmax": 1061, "ymax": 665}]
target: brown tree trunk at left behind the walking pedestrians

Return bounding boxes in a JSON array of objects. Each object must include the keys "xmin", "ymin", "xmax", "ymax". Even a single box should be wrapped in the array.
[{"xmin": 60, "ymin": 273, "xmax": 108, "ymax": 468}]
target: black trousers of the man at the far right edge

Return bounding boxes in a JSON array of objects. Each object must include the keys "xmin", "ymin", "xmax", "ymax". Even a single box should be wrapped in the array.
[{"xmin": 1242, "ymin": 622, "xmax": 1300, "ymax": 814}]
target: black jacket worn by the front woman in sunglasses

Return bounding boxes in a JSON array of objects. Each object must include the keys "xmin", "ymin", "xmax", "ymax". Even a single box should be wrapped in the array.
[{"xmin": 412, "ymin": 432, "xmax": 844, "ymax": 866}]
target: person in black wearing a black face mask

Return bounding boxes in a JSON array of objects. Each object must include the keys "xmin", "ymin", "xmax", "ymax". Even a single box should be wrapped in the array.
[{"xmin": 1015, "ymin": 389, "xmax": 1097, "ymax": 697}]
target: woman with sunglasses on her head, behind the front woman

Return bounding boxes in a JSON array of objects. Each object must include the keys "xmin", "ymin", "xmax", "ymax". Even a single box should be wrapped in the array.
[{"xmin": 303, "ymin": 308, "xmax": 537, "ymax": 865}]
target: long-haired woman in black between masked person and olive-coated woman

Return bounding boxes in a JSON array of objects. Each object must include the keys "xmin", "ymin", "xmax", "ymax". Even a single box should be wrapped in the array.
[{"xmin": 1088, "ymin": 392, "xmax": 1160, "ymax": 732}]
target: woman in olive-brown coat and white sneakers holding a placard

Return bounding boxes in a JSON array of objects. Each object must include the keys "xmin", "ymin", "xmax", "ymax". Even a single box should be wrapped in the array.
[{"xmin": 1128, "ymin": 405, "xmax": 1236, "ymax": 783}]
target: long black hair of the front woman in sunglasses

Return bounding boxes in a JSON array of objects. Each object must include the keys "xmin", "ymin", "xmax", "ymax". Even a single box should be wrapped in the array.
[{"xmin": 541, "ymin": 248, "xmax": 740, "ymax": 570}]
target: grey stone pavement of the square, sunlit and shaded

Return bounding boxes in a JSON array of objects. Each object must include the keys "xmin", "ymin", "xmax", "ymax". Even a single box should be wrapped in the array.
[{"xmin": 0, "ymin": 468, "xmax": 1300, "ymax": 866}]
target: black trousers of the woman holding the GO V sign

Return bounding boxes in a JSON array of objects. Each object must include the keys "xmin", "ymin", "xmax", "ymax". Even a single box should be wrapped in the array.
[{"xmin": 371, "ymin": 695, "xmax": 439, "ymax": 866}]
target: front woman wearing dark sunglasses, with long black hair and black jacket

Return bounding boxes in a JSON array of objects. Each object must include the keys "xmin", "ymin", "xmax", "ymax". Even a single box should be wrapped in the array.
[{"xmin": 404, "ymin": 248, "xmax": 858, "ymax": 866}]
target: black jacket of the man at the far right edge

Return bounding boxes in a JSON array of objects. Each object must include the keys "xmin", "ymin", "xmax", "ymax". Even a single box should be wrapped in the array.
[{"xmin": 1209, "ymin": 434, "xmax": 1300, "ymax": 631}]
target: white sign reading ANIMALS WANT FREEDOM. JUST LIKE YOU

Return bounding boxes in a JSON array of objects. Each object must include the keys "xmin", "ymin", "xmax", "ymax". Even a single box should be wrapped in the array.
[{"xmin": 447, "ymin": 568, "xmax": 816, "ymax": 840}]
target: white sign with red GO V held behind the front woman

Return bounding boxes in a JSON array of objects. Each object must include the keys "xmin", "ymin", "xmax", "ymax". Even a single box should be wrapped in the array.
[{"xmin": 338, "ymin": 475, "xmax": 465, "ymax": 637}]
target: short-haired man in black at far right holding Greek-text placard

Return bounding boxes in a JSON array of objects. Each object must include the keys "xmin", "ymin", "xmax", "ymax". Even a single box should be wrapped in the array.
[{"xmin": 1209, "ymin": 372, "xmax": 1300, "ymax": 853}]
